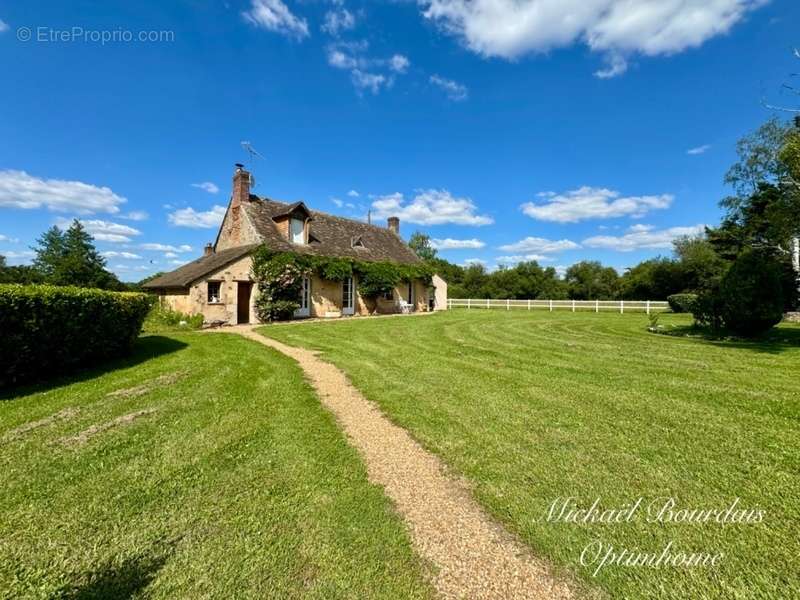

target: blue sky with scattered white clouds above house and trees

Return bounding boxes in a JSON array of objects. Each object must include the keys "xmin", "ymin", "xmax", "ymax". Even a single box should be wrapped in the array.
[{"xmin": 0, "ymin": 0, "xmax": 800, "ymax": 281}]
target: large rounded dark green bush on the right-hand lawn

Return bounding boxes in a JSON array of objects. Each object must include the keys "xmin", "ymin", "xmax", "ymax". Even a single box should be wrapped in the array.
[{"xmin": 720, "ymin": 251, "xmax": 783, "ymax": 336}]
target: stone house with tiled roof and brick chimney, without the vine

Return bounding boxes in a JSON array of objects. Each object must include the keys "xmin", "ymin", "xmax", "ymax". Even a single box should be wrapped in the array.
[{"xmin": 145, "ymin": 165, "xmax": 447, "ymax": 324}]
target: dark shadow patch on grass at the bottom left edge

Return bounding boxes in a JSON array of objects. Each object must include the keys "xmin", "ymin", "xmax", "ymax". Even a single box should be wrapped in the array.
[{"xmin": 51, "ymin": 551, "xmax": 171, "ymax": 600}]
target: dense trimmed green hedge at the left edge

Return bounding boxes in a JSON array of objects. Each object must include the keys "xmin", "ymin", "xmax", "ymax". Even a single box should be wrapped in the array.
[{"xmin": 0, "ymin": 285, "xmax": 153, "ymax": 387}]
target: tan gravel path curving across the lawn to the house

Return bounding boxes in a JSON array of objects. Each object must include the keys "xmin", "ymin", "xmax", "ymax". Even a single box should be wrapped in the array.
[{"xmin": 223, "ymin": 327, "xmax": 575, "ymax": 600}]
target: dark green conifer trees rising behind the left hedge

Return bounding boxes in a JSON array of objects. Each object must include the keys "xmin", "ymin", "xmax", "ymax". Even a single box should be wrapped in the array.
[{"xmin": 34, "ymin": 219, "xmax": 122, "ymax": 290}]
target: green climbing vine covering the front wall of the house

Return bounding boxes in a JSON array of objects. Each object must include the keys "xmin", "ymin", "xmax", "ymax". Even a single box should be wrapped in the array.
[{"xmin": 252, "ymin": 246, "xmax": 433, "ymax": 322}]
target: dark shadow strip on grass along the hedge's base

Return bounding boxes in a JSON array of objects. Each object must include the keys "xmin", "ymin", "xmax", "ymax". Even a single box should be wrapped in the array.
[{"xmin": 0, "ymin": 335, "xmax": 188, "ymax": 401}]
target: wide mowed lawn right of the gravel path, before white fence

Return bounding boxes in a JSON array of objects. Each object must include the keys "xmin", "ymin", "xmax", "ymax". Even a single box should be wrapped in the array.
[{"xmin": 260, "ymin": 310, "xmax": 800, "ymax": 598}]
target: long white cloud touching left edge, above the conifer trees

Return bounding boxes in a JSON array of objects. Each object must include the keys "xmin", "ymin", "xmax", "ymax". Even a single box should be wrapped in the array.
[{"xmin": 0, "ymin": 170, "xmax": 127, "ymax": 215}]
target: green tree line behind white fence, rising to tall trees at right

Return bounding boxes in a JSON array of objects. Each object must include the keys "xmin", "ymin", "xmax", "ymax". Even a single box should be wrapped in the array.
[{"xmin": 409, "ymin": 118, "xmax": 800, "ymax": 322}]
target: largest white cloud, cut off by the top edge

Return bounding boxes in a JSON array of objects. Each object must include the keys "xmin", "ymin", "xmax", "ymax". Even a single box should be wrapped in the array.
[{"xmin": 418, "ymin": 0, "xmax": 767, "ymax": 77}]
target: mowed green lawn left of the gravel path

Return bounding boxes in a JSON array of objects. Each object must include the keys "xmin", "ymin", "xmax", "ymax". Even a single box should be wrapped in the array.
[{"xmin": 0, "ymin": 333, "xmax": 431, "ymax": 599}]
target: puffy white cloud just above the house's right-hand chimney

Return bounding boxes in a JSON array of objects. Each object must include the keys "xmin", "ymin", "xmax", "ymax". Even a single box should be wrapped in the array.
[{"xmin": 372, "ymin": 190, "xmax": 494, "ymax": 225}]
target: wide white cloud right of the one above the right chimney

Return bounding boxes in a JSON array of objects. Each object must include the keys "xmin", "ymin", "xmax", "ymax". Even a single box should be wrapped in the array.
[{"xmin": 521, "ymin": 186, "xmax": 674, "ymax": 223}]
